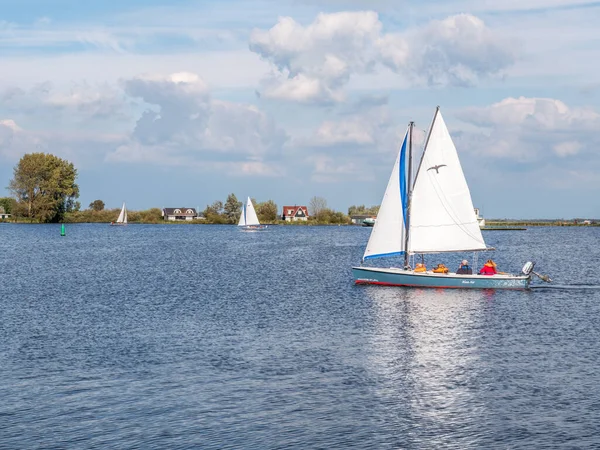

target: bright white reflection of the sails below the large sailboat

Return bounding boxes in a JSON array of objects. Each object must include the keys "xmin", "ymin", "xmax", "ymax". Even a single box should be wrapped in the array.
[{"xmin": 367, "ymin": 287, "xmax": 495, "ymax": 448}]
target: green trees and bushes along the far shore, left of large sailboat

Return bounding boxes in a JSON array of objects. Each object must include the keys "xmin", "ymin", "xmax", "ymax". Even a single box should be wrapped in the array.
[{"xmin": 0, "ymin": 153, "xmax": 379, "ymax": 224}]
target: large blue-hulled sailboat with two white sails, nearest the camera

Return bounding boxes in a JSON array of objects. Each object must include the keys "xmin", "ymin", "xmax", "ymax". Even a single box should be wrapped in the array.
[{"xmin": 352, "ymin": 106, "xmax": 550, "ymax": 289}]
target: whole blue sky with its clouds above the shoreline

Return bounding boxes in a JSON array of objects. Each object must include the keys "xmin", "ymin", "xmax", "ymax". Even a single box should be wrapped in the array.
[{"xmin": 0, "ymin": 0, "xmax": 600, "ymax": 218}]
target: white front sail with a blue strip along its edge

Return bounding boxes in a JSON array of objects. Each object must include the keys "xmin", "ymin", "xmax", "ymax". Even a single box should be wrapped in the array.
[{"xmin": 363, "ymin": 132, "xmax": 408, "ymax": 260}]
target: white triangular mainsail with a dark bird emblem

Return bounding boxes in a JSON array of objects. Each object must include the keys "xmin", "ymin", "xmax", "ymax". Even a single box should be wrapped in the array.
[{"xmin": 408, "ymin": 110, "xmax": 486, "ymax": 253}]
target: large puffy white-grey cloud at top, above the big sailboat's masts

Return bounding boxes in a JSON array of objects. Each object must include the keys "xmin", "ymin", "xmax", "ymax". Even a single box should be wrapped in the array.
[{"xmin": 249, "ymin": 11, "xmax": 515, "ymax": 104}]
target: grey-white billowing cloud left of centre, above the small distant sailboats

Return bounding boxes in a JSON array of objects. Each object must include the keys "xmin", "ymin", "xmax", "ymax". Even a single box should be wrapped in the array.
[{"xmin": 108, "ymin": 72, "xmax": 287, "ymax": 174}]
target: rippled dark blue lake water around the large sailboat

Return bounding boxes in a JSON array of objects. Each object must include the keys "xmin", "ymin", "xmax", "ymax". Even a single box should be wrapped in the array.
[{"xmin": 0, "ymin": 224, "xmax": 600, "ymax": 449}]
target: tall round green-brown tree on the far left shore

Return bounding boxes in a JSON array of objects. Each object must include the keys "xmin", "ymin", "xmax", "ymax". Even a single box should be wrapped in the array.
[{"xmin": 8, "ymin": 153, "xmax": 80, "ymax": 222}]
